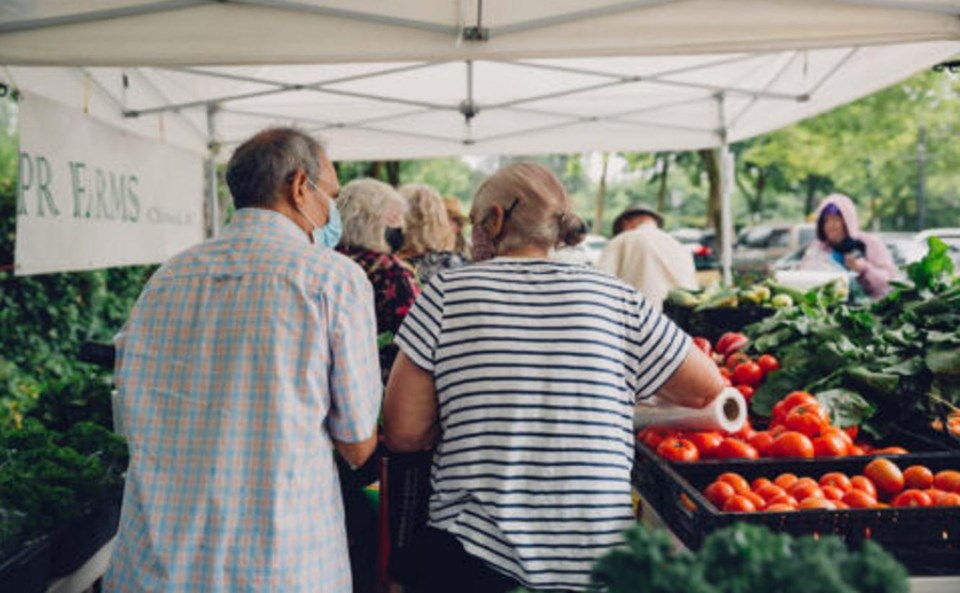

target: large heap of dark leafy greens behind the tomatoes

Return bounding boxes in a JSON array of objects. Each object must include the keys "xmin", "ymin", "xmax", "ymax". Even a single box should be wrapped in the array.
[{"xmin": 744, "ymin": 238, "xmax": 960, "ymax": 436}]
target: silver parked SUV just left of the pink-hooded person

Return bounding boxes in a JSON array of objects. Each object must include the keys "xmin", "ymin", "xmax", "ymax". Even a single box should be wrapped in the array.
[{"xmin": 733, "ymin": 222, "xmax": 817, "ymax": 274}]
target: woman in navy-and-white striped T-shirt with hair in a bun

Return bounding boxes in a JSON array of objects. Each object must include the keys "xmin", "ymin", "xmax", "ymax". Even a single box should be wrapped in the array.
[{"xmin": 384, "ymin": 163, "xmax": 724, "ymax": 593}]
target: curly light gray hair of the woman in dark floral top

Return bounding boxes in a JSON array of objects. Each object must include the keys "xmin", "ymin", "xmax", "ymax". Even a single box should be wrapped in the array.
[{"xmin": 337, "ymin": 178, "xmax": 408, "ymax": 253}]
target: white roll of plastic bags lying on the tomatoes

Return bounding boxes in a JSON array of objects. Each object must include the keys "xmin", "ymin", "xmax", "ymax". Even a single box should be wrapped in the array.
[{"xmin": 633, "ymin": 387, "xmax": 747, "ymax": 432}]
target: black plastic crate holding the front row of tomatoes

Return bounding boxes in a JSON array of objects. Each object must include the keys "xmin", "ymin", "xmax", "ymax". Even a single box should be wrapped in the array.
[{"xmin": 637, "ymin": 448, "xmax": 960, "ymax": 575}]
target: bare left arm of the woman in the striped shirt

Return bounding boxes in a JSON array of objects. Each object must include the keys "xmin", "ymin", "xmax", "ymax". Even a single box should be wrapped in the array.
[{"xmin": 383, "ymin": 351, "xmax": 439, "ymax": 453}]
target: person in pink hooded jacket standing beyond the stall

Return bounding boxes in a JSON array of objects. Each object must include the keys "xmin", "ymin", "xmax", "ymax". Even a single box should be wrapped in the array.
[{"xmin": 800, "ymin": 194, "xmax": 897, "ymax": 299}]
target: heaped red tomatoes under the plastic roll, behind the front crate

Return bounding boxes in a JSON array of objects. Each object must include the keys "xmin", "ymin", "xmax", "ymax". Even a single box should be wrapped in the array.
[{"xmin": 637, "ymin": 391, "xmax": 908, "ymax": 461}]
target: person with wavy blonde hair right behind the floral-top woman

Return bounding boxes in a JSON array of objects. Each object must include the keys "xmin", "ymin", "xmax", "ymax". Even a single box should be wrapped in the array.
[{"xmin": 398, "ymin": 183, "xmax": 467, "ymax": 284}]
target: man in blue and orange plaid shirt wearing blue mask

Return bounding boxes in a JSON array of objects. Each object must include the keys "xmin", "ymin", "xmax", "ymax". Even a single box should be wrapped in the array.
[{"xmin": 106, "ymin": 129, "xmax": 381, "ymax": 593}]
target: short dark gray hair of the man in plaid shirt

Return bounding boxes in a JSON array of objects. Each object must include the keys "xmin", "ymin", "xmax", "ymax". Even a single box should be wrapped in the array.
[{"xmin": 226, "ymin": 128, "xmax": 323, "ymax": 209}]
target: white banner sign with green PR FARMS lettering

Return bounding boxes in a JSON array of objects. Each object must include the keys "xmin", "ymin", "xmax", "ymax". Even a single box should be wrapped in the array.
[{"xmin": 15, "ymin": 94, "xmax": 204, "ymax": 275}]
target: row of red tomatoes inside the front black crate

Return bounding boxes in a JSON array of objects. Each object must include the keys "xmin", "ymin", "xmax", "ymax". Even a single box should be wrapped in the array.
[{"xmin": 703, "ymin": 457, "xmax": 960, "ymax": 513}]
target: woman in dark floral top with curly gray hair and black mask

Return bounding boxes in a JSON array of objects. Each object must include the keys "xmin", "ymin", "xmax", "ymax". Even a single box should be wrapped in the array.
[{"xmin": 337, "ymin": 179, "xmax": 420, "ymax": 384}]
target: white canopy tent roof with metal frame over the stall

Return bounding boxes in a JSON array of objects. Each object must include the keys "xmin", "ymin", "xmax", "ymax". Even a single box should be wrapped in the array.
[{"xmin": 0, "ymin": 0, "xmax": 960, "ymax": 278}]
